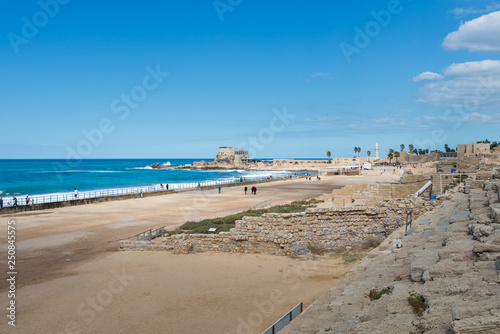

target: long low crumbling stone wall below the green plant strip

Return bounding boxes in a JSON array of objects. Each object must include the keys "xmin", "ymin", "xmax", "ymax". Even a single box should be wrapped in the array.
[{"xmin": 120, "ymin": 207, "xmax": 402, "ymax": 255}]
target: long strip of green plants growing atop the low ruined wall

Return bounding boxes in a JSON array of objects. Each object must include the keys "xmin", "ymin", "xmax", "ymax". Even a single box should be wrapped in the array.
[{"xmin": 178, "ymin": 199, "xmax": 322, "ymax": 235}]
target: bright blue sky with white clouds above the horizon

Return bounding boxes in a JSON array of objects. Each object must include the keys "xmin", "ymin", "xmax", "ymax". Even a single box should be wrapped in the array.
[{"xmin": 0, "ymin": 0, "xmax": 500, "ymax": 158}]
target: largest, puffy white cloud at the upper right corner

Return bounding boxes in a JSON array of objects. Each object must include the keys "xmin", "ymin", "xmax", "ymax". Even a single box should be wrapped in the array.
[{"xmin": 443, "ymin": 11, "xmax": 500, "ymax": 52}]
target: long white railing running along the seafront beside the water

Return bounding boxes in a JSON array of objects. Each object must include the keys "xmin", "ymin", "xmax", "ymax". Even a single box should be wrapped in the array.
[{"xmin": 3, "ymin": 172, "xmax": 317, "ymax": 208}]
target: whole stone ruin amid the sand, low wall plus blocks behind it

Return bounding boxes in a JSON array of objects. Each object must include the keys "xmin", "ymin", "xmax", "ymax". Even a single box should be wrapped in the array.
[{"xmin": 120, "ymin": 176, "xmax": 434, "ymax": 255}]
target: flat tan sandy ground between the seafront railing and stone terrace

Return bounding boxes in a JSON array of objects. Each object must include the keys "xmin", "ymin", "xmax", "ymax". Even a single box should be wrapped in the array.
[{"xmin": 0, "ymin": 175, "xmax": 393, "ymax": 333}]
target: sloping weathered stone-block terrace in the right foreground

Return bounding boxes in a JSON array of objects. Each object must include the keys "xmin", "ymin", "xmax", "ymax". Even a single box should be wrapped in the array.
[{"xmin": 280, "ymin": 180, "xmax": 500, "ymax": 334}]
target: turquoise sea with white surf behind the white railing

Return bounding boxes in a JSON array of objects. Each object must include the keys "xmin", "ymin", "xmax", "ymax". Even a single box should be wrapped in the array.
[{"xmin": 0, "ymin": 159, "xmax": 289, "ymax": 199}]
